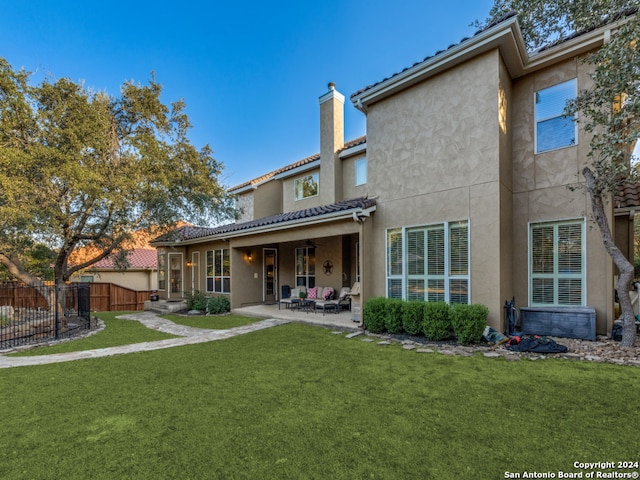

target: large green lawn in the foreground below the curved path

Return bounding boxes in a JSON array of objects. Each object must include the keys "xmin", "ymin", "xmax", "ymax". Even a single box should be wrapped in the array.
[{"xmin": 0, "ymin": 318, "xmax": 640, "ymax": 480}]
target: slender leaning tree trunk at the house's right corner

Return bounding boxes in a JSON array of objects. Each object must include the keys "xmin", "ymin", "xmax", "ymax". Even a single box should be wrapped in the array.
[{"xmin": 582, "ymin": 167, "xmax": 636, "ymax": 347}]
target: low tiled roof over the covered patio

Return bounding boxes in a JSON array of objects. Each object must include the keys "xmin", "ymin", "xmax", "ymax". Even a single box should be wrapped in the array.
[{"xmin": 152, "ymin": 197, "xmax": 376, "ymax": 244}]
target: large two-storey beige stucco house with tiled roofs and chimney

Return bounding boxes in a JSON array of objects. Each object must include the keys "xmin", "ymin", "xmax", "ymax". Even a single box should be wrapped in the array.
[{"xmin": 152, "ymin": 11, "xmax": 632, "ymax": 333}]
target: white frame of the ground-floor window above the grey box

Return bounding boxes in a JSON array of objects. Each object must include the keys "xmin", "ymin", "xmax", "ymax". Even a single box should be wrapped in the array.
[{"xmin": 527, "ymin": 218, "xmax": 587, "ymax": 307}]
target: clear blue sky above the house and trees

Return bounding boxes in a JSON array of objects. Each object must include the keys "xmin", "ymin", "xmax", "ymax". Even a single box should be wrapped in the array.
[{"xmin": 0, "ymin": 0, "xmax": 493, "ymax": 186}]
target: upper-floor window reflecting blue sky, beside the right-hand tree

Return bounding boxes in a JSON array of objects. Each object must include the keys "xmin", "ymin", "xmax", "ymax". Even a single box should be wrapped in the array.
[{"xmin": 535, "ymin": 79, "xmax": 577, "ymax": 153}]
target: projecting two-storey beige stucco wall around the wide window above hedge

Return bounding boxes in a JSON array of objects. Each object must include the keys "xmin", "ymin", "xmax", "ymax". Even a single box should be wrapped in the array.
[{"xmin": 367, "ymin": 51, "xmax": 510, "ymax": 324}]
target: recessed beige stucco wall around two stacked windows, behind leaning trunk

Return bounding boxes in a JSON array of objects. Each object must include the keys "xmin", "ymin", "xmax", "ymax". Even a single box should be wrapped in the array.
[{"xmin": 512, "ymin": 59, "xmax": 613, "ymax": 333}]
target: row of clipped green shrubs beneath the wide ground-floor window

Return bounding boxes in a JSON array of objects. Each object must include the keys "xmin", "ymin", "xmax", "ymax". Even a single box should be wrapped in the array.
[{"xmin": 362, "ymin": 297, "xmax": 489, "ymax": 344}]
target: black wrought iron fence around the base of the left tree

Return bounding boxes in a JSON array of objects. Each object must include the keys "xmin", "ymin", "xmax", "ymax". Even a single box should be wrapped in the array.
[{"xmin": 0, "ymin": 283, "xmax": 96, "ymax": 350}]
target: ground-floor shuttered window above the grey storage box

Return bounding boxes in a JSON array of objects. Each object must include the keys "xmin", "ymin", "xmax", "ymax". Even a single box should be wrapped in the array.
[{"xmin": 529, "ymin": 220, "xmax": 585, "ymax": 306}]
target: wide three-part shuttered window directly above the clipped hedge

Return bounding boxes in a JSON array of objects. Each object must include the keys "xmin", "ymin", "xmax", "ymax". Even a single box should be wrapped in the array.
[{"xmin": 387, "ymin": 221, "xmax": 470, "ymax": 303}]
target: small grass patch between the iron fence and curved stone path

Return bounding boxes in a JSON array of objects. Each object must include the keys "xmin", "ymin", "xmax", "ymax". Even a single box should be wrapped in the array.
[{"xmin": 11, "ymin": 312, "xmax": 175, "ymax": 357}]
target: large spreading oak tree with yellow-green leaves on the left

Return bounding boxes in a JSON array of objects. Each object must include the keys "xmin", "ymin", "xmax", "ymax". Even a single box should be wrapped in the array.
[{"xmin": 0, "ymin": 58, "xmax": 232, "ymax": 282}]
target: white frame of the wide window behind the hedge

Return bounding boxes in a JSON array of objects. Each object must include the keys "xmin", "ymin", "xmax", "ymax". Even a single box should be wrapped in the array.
[{"xmin": 385, "ymin": 220, "xmax": 471, "ymax": 303}]
